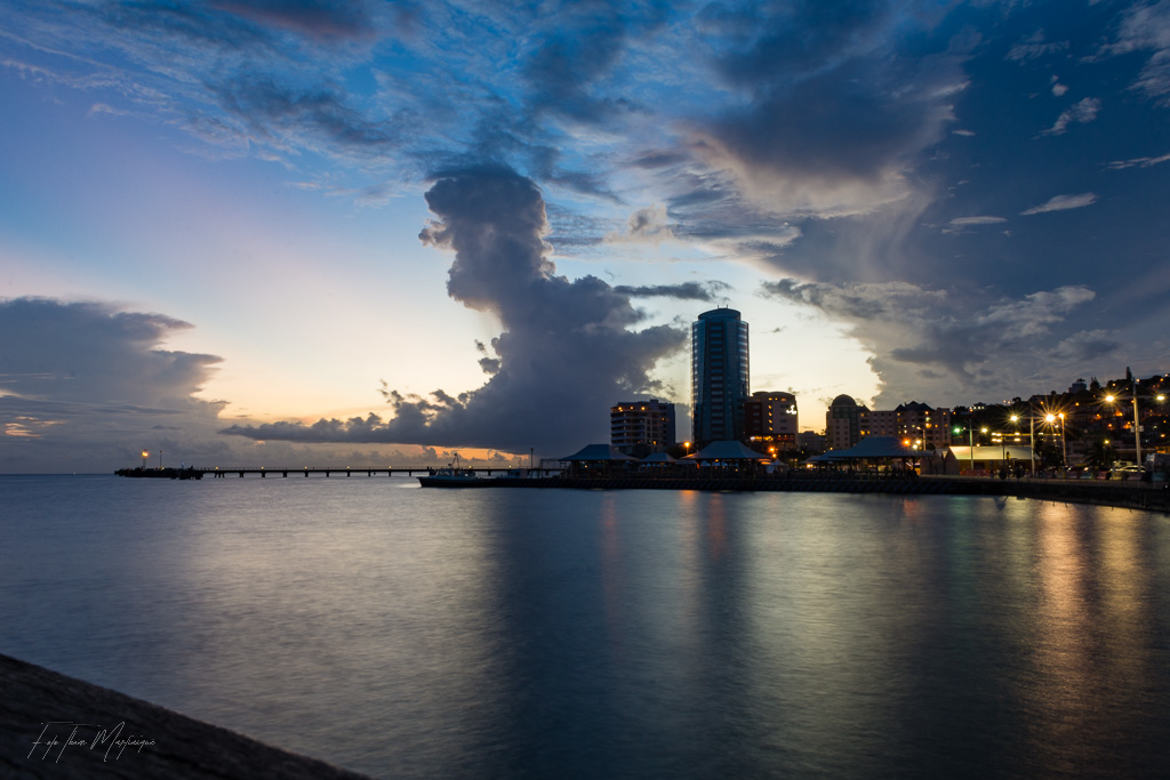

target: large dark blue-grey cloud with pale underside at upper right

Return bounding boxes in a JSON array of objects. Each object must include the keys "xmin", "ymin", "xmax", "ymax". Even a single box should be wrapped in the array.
[{"xmin": 689, "ymin": 2, "xmax": 966, "ymax": 216}]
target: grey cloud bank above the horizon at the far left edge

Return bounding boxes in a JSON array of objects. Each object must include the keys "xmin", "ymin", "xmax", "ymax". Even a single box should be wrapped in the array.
[{"xmin": 0, "ymin": 298, "xmax": 222, "ymax": 471}]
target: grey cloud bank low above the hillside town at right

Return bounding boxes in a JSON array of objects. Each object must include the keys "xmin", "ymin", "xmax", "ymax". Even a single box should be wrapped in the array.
[{"xmin": 764, "ymin": 278, "xmax": 1120, "ymax": 403}]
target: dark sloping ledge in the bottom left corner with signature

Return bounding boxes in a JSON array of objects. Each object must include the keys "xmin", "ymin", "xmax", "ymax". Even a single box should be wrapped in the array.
[{"xmin": 0, "ymin": 655, "xmax": 365, "ymax": 780}]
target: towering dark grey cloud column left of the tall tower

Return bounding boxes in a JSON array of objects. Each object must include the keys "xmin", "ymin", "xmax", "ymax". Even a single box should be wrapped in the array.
[{"xmin": 225, "ymin": 167, "xmax": 686, "ymax": 455}]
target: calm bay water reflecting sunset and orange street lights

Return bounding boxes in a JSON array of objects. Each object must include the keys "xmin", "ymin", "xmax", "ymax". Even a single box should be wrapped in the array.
[{"xmin": 0, "ymin": 476, "xmax": 1170, "ymax": 778}]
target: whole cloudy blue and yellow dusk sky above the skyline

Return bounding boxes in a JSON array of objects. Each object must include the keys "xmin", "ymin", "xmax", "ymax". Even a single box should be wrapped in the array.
[{"xmin": 0, "ymin": 0, "xmax": 1170, "ymax": 472}]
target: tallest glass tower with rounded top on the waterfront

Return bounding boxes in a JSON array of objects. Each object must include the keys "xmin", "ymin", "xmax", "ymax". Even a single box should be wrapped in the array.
[{"xmin": 690, "ymin": 309, "xmax": 748, "ymax": 446}]
